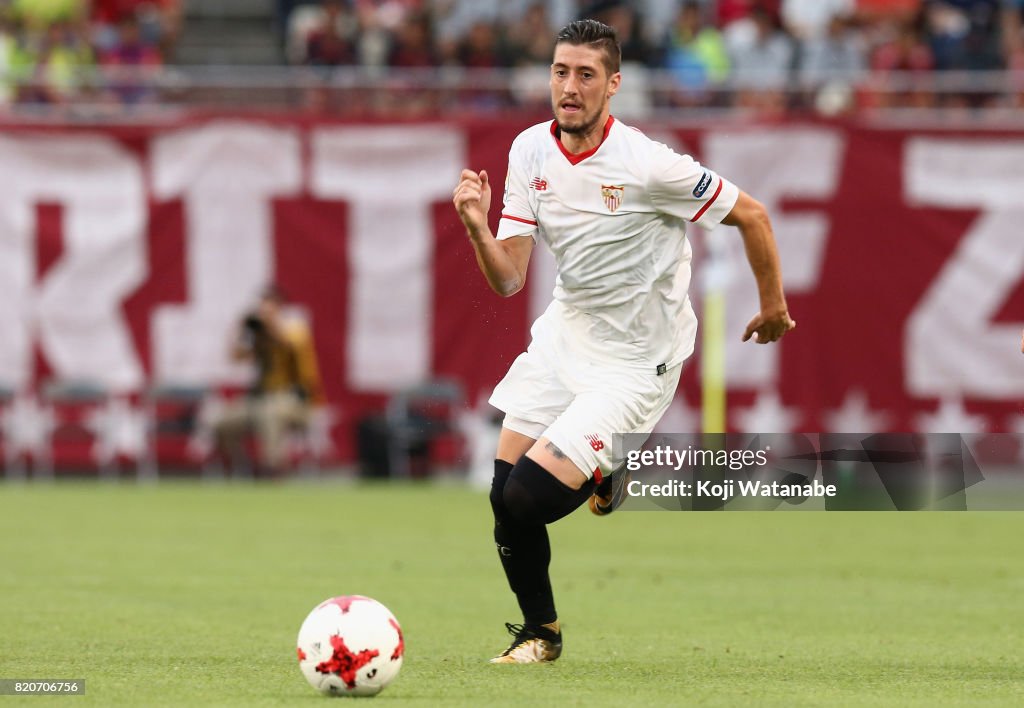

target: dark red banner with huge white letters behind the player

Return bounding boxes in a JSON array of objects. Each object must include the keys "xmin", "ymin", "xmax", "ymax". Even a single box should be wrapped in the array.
[{"xmin": 0, "ymin": 117, "xmax": 1024, "ymax": 459}]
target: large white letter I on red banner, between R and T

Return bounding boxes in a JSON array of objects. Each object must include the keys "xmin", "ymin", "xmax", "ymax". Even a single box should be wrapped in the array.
[{"xmin": 153, "ymin": 122, "xmax": 302, "ymax": 383}]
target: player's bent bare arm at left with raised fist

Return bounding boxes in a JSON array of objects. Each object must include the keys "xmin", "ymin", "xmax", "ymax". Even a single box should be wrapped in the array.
[{"xmin": 452, "ymin": 170, "xmax": 534, "ymax": 297}]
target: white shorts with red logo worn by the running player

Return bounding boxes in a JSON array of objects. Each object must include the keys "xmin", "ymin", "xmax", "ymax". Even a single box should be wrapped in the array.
[{"xmin": 490, "ymin": 305, "xmax": 683, "ymax": 481}]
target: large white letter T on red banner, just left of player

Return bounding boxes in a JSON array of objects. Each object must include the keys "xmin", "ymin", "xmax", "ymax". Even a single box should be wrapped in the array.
[{"xmin": 310, "ymin": 127, "xmax": 466, "ymax": 390}]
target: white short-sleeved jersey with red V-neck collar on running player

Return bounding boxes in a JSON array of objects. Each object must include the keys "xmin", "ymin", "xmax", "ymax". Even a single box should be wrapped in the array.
[{"xmin": 497, "ymin": 117, "xmax": 739, "ymax": 371}]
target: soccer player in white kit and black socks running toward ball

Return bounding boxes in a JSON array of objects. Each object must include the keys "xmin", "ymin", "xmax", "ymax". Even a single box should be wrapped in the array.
[{"xmin": 453, "ymin": 19, "xmax": 796, "ymax": 664}]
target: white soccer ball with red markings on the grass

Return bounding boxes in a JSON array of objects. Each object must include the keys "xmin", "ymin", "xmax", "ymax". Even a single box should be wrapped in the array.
[{"xmin": 298, "ymin": 595, "xmax": 406, "ymax": 696}]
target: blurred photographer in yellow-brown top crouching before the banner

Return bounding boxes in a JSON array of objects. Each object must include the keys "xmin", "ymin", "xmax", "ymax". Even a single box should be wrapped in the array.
[{"xmin": 214, "ymin": 286, "xmax": 325, "ymax": 475}]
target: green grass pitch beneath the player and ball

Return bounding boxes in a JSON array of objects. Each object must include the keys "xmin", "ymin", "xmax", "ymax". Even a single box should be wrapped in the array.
[{"xmin": 0, "ymin": 483, "xmax": 1024, "ymax": 706}]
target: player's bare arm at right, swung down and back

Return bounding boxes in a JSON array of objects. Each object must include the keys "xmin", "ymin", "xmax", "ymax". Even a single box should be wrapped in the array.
[{"xmin": 722, "ymin": 190, "xmax": 797, "ymax": 344}]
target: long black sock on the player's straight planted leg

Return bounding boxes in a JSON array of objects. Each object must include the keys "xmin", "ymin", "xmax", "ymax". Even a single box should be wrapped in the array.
[{"xmin": 490, "ymin": 460, "xmax": 558, "ymax": 625}]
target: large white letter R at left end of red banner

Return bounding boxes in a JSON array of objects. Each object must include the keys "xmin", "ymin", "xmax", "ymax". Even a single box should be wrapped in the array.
[{"xmin": 0, "ymin": 136, "xmax": 145, "ymax": 391}]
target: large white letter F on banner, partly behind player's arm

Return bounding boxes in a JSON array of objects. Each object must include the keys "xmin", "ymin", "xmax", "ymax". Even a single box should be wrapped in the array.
[{"xmin": 703, "ymin": 127, "xmax": 846, "ymax": 388}]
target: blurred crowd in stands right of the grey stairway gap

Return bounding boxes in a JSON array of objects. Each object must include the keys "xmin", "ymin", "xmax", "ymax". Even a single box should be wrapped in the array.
[{"xmin": 281, "ymin": 0, "xmax": 1024, "ymax": 112}]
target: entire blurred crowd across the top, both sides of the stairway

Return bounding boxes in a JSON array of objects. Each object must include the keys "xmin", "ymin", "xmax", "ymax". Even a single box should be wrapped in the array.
[{"xmin": 0, "ymin": 0, "xmax": 1024, "ymax": 112}]
